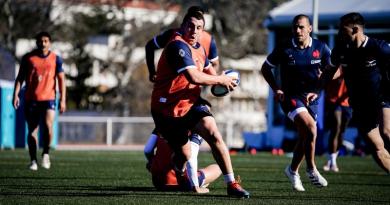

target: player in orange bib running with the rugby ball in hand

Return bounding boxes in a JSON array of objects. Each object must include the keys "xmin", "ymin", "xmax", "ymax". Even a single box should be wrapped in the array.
[{"xmin": 151, "ymin": 12, "xmax": 249, "ymax": 198}]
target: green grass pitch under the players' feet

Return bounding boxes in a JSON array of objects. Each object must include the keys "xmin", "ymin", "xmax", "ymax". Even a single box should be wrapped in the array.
[{"xmin": 0, "ymin": 150, "xmax": 390, "ymax": 205}]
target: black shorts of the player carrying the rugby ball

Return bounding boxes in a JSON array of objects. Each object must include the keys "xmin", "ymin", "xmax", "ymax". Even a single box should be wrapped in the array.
[{"xmin": 152, "ymin": 101, "xmax": 213, "ymax": 150}]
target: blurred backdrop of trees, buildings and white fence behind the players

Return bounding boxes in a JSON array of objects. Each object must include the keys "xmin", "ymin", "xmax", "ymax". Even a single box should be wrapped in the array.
[{"xmin": 0, "ymin": 0, "xmax": 390, "ymax": 153}]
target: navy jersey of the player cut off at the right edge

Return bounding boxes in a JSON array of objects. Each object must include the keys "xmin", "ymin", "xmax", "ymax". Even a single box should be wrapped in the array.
[{"xmin": 331, "ymin": 37, "xmax": 390, "ymax": 107}]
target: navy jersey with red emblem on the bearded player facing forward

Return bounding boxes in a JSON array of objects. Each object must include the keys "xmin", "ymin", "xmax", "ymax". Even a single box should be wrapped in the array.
[{"xmin": 266, "ymin": 38, "xmax": 330, "ymax": 98}]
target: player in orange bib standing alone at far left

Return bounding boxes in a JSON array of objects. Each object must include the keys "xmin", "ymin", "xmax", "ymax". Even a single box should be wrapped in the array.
[{"xmin": 13, "ymin": 32, "xmax": 66, "ymax": 171}]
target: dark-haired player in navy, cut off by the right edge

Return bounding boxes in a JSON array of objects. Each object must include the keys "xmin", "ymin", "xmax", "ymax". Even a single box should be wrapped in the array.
[{"xmin": 324, "ymin": 12, "xmax": 390, "ymax": 172}]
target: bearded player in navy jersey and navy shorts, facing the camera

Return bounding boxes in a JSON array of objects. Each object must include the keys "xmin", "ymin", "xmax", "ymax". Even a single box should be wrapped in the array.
[{"xmin": 261, "ymin": 14, "xmax": 330, "ymax": 191}]
